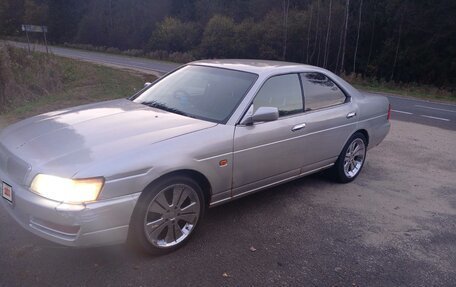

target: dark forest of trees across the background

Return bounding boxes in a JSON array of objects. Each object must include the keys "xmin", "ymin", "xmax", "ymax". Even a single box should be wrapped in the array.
[{"xmin": 0, "ymin": 0, "xmax": 456, "ymax": 91}]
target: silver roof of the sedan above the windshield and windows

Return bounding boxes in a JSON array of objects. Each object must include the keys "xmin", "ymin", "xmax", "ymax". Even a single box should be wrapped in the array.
[{"xmin": 189, "ymin": 59, "xmax": 322, "ymax": 75}]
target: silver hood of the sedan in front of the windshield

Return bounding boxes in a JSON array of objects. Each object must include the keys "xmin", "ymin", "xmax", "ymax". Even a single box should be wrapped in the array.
[{"xmin": 0, "ymin": 99, "xmax": 216, "ymax": 177}]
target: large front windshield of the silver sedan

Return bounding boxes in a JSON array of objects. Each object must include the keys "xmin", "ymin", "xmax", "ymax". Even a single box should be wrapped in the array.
[{"xmin": 133, "ymin": 65, "xmax": 258, "ymax": 123}]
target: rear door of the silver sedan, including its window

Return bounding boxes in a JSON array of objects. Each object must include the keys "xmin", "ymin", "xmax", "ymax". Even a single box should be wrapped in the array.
[{"xmin": 300, "ymin": 72, "xmax": 358, "ymax": 172}]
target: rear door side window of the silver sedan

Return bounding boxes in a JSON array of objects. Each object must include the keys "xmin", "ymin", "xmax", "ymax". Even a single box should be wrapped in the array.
[{"xmin": 301, "ymin": 72, "xmax": 346, "ymax": 111}]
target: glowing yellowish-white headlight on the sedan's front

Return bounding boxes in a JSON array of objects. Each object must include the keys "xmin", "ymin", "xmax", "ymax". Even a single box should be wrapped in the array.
[{"xmin": 30, "ymin": 174, "xmax": 104, "ymax": 203}]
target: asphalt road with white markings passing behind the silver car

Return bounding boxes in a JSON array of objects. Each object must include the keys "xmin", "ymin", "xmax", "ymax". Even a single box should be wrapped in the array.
[{"xmin": 5, "ymin": 42, "xmax": 456, "ymax": 130}]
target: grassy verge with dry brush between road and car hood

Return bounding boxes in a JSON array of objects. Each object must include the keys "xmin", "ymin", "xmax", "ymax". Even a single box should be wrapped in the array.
[{"xmin": 0, "ymin": 44, "xmax": 154, "ymax": 122}]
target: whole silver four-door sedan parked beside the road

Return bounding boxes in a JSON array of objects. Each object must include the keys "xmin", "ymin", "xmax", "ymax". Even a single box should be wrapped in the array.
[{"xmin": 0, "ymin": 60, "xmax": 390, "ymax": 254}]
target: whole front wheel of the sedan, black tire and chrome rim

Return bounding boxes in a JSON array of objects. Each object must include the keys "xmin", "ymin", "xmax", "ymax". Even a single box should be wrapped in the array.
[{"xmin": 128, "ymin": 175, "xmax": 206, "ymax": 255}]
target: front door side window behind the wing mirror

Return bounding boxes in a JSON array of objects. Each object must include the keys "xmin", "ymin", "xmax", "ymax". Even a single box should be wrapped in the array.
[{"xmin": 253, "ymin": 74, "xmax": 303, "ymax": 117}]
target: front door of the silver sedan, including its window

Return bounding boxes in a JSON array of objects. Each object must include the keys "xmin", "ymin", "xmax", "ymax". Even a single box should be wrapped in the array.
[{"xmin": 233, "ymin": 74, "xmax": 304, "ymax": 196}]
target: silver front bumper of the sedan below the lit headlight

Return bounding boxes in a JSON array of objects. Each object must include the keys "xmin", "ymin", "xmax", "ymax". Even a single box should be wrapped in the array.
[{"xmin": 0, "ymin": 170, "xmax": 140, "ymax": 247}]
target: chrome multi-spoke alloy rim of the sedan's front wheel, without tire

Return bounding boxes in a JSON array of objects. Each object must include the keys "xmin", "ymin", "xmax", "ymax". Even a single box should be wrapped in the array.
[{"xmin": 144, "ymin": 184, "xmax": 201, "ymax": 248}]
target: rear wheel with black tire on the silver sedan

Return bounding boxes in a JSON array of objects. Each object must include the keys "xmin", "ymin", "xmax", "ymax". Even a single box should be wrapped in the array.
[{"xmin": 332, "ymin": 132, "xmax": 367, "ymax": 183}]
